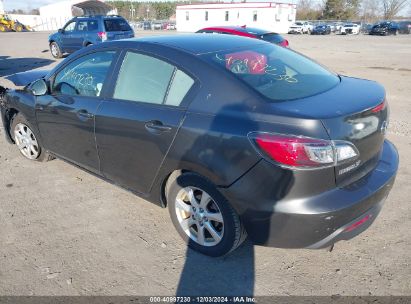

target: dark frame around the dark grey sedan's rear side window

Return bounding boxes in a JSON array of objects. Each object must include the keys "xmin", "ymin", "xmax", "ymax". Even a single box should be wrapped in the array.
[{"xmin": 105, "ymin": 48, "xmax": 201, "ymax": 110}]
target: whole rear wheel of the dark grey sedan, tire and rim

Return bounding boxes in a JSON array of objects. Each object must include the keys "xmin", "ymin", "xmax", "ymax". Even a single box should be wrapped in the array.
[{"xmin": 167, "ymin": 173, "xmax": 246, "ymax": 257}]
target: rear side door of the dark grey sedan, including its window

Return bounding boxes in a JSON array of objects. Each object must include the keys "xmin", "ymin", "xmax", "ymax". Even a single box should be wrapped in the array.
[{"xmin": 96, "ymin": 51, "xmax": 197, "ymax": 193}]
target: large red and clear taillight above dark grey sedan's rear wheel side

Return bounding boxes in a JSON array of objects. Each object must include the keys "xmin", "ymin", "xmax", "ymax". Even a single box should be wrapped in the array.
[{"xmin": 249, "ymin": 132, "xmax": 359, "ymax": 169}]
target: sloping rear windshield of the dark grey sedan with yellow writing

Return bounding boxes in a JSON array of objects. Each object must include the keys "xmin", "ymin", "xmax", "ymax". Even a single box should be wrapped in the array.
[{"xmin": 202, "ymin": 44, "xmax": 340, "ymax": 102}]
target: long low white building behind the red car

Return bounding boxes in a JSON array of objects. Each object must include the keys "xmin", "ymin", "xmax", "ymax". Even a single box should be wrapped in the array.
[{"xmin": 176, "ymin": 1, "xmax": 297, "ymax": 33}]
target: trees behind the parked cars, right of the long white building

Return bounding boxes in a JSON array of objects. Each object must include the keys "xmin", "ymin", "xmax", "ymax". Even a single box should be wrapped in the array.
[{"xmin": 297, "ymin": 0, "xmax": 411, "ymax": 21}]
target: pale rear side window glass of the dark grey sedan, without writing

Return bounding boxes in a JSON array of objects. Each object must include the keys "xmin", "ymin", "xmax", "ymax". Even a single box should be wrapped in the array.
[{"xmin": 113, "ymin": 52, "xmax": 194, "ymax": 106}]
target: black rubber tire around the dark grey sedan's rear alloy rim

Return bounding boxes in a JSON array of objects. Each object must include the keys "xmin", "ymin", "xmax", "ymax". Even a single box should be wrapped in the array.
[{"xmin": 166, "ymin": 173, "xmax": 247, "ymax": 257}]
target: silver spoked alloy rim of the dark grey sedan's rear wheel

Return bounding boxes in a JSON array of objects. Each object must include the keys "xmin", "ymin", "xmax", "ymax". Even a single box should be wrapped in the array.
[{"xmin": 175, "ymin": 187, "xmax": 224, "ymax": 247}]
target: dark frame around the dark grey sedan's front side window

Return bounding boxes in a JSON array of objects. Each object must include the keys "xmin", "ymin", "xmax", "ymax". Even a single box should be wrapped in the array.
[{"xmin": 47, "ymin": 47, "xmax": 121, "ymax": 99}]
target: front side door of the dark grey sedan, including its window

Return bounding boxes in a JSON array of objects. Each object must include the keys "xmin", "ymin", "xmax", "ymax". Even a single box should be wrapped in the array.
[{"xmin": 36, "ymin": 50, "xmax": 116, "ymax": 173}]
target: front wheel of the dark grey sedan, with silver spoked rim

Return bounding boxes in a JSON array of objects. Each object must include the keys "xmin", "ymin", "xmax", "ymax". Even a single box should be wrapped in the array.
[{"xmin": 10, "ymin": 114, "xmax": 52, "ymax": 161}]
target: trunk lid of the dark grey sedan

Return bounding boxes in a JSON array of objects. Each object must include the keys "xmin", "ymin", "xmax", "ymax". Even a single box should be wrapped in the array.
[{"xmin": 268, "ymin": 77, "xmax": 388, "ymax": 186}]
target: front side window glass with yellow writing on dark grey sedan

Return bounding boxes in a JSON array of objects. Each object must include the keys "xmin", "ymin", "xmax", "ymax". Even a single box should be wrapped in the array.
[{"xmin": 51, "ymin": 51, "xmax": 115, "ymax": 97}]
